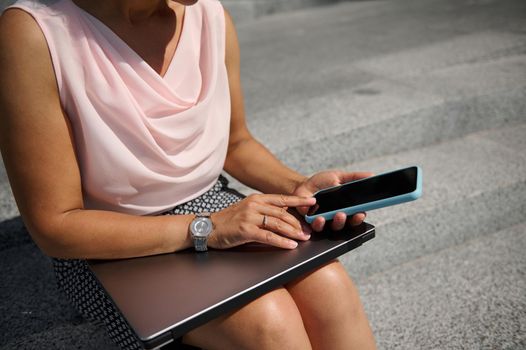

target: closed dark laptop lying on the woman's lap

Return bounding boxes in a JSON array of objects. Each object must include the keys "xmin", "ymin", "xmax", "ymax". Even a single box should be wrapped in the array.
[{"xmin": 89, "ymin": 223, "xmax": 375, "ymax": 349}]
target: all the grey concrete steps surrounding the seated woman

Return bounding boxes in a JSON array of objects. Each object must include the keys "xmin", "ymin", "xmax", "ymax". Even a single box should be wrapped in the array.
[{"xmin": 0, "ymin": 0, "xmax": 526, "ymax": 350}]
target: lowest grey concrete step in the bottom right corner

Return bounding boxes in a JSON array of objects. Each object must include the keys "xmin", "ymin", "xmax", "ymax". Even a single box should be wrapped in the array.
[{"xmin": 355, "ymin": 223, "xmax": 526, "ymax": 349}]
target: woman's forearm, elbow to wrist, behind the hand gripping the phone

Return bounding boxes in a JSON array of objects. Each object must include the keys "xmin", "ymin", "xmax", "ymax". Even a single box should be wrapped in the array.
[{"xmin": 225, "ymin": 137, "xmax": 306, "ymax": 194}]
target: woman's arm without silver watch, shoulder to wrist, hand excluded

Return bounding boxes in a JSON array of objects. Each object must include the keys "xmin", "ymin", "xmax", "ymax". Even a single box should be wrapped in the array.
[{"xmin": 225, "ymin": 11, "xmax": 306, "ymax": 194}]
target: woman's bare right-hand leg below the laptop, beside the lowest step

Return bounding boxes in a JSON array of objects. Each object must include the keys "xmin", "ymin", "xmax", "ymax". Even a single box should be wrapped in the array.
[{"xmin": 286, "ymin": 260, "xmax": 376, "ymax": 350}]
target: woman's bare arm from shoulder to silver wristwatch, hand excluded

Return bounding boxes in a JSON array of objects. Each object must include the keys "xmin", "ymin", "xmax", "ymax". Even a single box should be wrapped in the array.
[{"xmin": 0, "ymin": 9, "xmax": 196, "ymax": 258}]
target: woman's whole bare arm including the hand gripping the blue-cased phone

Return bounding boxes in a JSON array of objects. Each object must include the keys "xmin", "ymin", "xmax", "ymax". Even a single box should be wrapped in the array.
[{"xmin": 225, "ymin": 12, "xmax": 372, "ymax": 231}]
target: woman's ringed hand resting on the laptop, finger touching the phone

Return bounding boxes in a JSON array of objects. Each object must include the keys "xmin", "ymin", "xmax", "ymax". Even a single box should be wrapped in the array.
[{"xmin": 208, "ymin": 194, "xmax": 316, "ymax": 249}]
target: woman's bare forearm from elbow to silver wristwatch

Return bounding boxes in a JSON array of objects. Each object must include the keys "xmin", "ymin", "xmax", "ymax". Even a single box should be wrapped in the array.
[{"xmin": 35, "ymin": 209, "xmax": 193, "ymax": 259}]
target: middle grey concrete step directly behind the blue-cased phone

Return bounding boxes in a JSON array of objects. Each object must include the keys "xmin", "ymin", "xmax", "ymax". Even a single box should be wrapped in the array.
[{"xmin": 342, "ymin": 124, "xmax": 526, "ymax": 276}]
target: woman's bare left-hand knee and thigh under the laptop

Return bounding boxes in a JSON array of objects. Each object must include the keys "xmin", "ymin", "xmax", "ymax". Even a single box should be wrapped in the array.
[{"xmin": 183, "ymin": 288, "xmax": 311, "ymax": 349}]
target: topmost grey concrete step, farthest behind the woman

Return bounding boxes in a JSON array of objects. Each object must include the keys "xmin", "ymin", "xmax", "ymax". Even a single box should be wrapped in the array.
[{"xmin": 238, "ymin": 0, "xmax": 526, "ymax": 118}]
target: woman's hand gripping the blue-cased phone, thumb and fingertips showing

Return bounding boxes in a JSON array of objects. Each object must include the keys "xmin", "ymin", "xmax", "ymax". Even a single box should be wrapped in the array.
[{"xmin": 293, "ymin": 170, "xmax": 373, "ymax": 232}]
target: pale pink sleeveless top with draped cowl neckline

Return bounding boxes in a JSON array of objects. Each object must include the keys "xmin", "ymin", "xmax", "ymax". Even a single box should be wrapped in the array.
[{"xmin": 7, "ymin": 0, "xmax": 230, "ymax": 215}]
